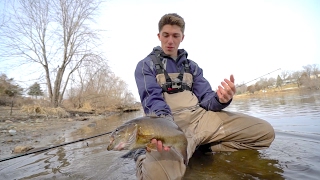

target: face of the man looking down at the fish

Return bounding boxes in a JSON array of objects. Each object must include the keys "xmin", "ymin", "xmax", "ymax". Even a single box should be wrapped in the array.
[{"xmin": 158, "ymin": 24, "xmax": 184, "ymax": 57}]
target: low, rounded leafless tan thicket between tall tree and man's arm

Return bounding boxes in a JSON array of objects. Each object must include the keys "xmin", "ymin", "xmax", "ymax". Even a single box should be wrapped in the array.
[{"xmin": 68, "ymin": 62, "xmax": 135, "ymax": 110}]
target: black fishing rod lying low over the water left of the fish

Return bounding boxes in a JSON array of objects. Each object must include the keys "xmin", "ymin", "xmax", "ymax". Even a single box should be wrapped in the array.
[{"xmin": 0, "ymin": 131, "xmax": 112, "ymax": 162}]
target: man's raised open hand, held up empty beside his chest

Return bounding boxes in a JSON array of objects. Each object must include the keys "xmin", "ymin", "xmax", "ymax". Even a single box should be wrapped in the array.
[{"xmin": 217, "ymin": 75, "xmax": 236, "ymax": 103}]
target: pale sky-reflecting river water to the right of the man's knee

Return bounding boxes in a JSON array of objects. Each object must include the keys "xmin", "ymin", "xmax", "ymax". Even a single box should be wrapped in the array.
[{"xmin": 227, "ymin": 91, "xmax": 320, "ymax": 179}]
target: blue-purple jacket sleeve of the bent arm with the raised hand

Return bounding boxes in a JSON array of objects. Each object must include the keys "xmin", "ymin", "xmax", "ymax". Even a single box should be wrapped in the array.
[{"xmin": 190, "ymin": 61, "xmax": 232, "ymax": 111}]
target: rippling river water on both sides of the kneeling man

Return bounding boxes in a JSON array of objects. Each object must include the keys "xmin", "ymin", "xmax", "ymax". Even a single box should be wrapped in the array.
[{"xmin": 0, "ymin": 91, "xmax": 320, "ymax": 180}]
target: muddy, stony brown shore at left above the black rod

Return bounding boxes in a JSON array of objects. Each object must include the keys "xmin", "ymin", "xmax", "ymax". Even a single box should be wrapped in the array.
[{"xmin": 0, "ymin": 106, "xmax": 112, "ymax": 159}]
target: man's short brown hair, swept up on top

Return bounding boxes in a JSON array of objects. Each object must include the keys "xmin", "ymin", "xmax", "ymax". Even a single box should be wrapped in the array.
[{"xmin": 158, "ymin": 13, "xmax": 185, "ymax": 34}]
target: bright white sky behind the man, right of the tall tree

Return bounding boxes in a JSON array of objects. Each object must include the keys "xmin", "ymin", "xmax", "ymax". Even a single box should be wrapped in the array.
[{"xmin": 0, "ymin": 0, "xmax": 320, "ymax": 100}]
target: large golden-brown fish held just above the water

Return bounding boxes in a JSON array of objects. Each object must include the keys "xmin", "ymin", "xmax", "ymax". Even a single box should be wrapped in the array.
[{"xmin": 107, "ymin": 116, "xmax": 188, "ymax": 164}]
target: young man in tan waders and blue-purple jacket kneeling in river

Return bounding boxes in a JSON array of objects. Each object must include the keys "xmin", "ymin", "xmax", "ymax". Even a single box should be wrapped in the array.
[{"xmin": 135, "ymin": 13, "xmax": 275, "ymax": 180}]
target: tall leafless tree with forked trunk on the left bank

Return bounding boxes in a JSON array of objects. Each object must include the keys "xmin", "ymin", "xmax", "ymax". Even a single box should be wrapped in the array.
[{"xmin": 1, "ymin": 0, "xmax": 103, "ymax": 107}]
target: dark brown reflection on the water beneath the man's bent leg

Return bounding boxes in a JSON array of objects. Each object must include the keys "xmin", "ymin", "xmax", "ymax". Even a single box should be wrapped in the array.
[{"xmin": 185, "ymin": 150, "xmax": 284, "ymax": 180}]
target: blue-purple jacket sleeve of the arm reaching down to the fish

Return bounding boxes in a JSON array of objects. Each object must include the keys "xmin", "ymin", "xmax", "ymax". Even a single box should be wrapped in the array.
[{"xmin": 134, "ymin": 60, "xmax": 171, "ymax": 116}]
